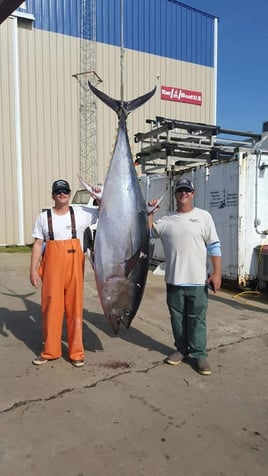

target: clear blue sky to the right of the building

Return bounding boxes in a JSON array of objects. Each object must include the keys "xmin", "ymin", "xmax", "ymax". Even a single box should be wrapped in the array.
[{"xmin": 181, "ymin": 0, "xmax": 268, "ymax": 133}]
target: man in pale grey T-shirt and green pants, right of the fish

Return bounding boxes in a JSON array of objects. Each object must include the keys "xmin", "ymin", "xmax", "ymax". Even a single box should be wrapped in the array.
[{"xmin": 149, "ymin": 179, "xmax": 221, "ymax": 375}]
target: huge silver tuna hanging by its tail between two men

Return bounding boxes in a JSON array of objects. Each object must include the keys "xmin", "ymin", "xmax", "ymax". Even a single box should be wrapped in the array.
[{"xmin": 89, "ymin": 82, "xmax": 156, "ymax": 334}]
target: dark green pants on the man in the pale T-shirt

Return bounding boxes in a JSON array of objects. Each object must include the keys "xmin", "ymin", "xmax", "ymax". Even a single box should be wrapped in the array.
[{"xmin": 167, "ymin": 284, "xmax": 208, "ymax": 359}]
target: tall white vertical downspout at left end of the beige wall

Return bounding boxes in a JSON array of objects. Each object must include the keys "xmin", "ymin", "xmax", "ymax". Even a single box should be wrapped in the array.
[{"xmin": 11, "ymin": 17, "xmax": 25, "ymax": 245}]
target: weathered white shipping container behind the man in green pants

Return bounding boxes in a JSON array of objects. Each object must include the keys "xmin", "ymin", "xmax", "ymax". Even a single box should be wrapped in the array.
[{"xmin": 141, "ymin": 151, "xmax": 268, "ymax": 287}]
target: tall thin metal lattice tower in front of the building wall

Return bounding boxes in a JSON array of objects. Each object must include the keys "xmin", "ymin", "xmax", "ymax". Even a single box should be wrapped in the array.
[{"xmin": 74, "ymin": 0, "xmax": 102, "ymax": 185}]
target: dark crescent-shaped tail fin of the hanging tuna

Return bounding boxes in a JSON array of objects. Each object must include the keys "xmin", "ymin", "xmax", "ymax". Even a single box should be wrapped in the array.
[{"xmin": 88, "ymin": 81, "xmax": 156, "ymax": 117}]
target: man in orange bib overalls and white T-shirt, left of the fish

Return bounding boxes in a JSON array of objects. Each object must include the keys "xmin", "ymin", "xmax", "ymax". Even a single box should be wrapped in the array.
[{"xmin": 30, "ymin": 179, "xmax": 98, "ymax": 367}]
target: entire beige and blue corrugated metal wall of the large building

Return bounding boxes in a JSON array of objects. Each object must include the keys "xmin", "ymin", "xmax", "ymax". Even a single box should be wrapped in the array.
[{"xmin": 0, "ymin": 0, "xmax": 215, "ymax": 245}]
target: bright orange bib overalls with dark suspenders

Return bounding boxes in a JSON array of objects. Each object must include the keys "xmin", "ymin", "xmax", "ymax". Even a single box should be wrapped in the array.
[{"xmin": 39, "ymin": 207, "xmax": 84, "ymax": 360}]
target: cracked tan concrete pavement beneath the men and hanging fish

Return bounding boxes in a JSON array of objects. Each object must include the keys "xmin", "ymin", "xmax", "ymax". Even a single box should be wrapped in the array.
[{"xmin": 0, "ymin": 253, "xmax": 268, "ymax": 476}]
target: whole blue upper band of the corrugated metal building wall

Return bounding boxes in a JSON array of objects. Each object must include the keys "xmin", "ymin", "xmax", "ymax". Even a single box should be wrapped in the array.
[{"xmin": 19, "ymin": 0, "xmax": 214, "ymax": 67}]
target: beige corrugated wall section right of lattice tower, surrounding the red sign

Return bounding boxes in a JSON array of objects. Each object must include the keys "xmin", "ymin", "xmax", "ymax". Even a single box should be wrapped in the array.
[{"xmin": 97, "ymin": 43, "xmax": 214, "ymax": 180}]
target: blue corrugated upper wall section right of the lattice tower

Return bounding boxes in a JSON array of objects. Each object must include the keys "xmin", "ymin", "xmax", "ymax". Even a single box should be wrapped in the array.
[{"xmin": 97, "ymin": 0, "xmax": 214, "ymax": 66}]
